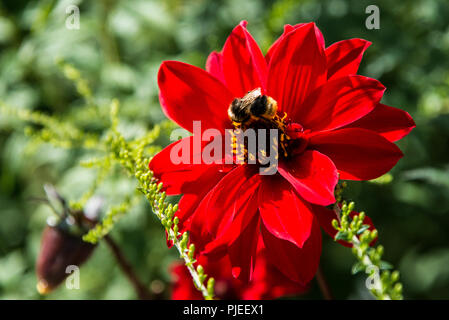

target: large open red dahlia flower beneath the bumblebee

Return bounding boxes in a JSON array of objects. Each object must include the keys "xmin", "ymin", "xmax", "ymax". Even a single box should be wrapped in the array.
[{"xmin": 150, "ymin": 22, "xmax": 415, "ymax": 285}]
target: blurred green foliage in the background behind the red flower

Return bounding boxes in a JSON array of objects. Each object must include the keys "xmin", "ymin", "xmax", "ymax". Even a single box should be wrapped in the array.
[{"xmin": 0, "ymin": 0, "xmax": 449, "ymax": 299}]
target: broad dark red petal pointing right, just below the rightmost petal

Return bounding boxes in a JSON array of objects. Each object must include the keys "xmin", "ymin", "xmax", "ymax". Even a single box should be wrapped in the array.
[{"xmin": 309, "ymin": 128, "xmax": 403, "ymax": 180}]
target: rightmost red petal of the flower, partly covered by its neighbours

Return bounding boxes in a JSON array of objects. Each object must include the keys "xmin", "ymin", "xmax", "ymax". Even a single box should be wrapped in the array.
[{"xmin": 346, "ymin": 103, "xmax": 416, "ymax": 142}]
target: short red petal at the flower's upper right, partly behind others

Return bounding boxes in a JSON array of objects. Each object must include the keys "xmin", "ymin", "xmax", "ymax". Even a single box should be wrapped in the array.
[{"xmin": 326, "ymin": 39, "xmax": 371, "ymax": 79}]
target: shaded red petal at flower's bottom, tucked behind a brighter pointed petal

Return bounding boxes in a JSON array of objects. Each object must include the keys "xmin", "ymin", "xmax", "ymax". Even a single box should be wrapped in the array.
[{"xmin": 261, "ymin": 219, "xmax": 321, "ymax": 285}]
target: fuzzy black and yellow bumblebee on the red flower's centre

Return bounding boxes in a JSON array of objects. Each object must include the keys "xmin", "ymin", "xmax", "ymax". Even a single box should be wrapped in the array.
[{"xmin": 228, "ymin": 88, "xmax": 277, "ymax": 127}]
